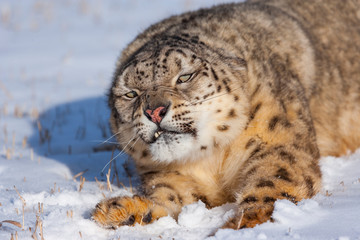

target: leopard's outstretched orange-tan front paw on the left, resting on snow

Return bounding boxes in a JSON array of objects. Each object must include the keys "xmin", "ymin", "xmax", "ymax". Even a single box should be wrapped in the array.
[{"xmin": 92, "ymin": 196, "xmax": 161, "ymax": 229}]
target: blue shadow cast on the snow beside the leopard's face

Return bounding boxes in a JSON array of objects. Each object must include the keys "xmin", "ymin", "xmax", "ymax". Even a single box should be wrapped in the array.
[{"xmin": 29, "ymin": 96, "xmax": 134, "ymax": 186}]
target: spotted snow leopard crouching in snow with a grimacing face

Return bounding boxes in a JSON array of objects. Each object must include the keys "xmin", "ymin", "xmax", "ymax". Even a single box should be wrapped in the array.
[{"xmin": 92, "ymin": 0, "xmax": 360, "ymax": 229}]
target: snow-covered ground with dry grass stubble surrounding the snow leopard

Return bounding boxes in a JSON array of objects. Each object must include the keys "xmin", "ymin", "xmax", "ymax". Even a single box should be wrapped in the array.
[{"xmin": 0, "ymin": 0, "xmax": 360, "ymax": 240}]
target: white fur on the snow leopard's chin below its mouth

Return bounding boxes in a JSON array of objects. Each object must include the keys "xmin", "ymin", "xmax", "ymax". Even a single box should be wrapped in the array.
[{"xmin": 150, "ymin": 134, "xmax": 196, "ymax": 163}]
